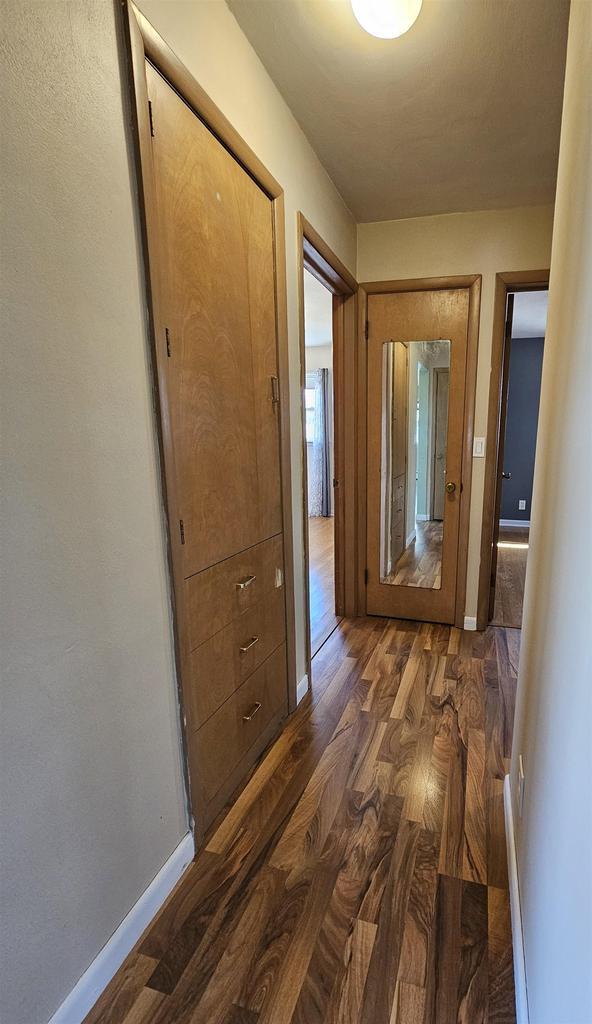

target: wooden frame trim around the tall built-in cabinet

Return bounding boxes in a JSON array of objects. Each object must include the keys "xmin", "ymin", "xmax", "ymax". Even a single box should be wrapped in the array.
[{"xmin": 120, "ymin": 0, "xmax": 296, "ymax": 841}]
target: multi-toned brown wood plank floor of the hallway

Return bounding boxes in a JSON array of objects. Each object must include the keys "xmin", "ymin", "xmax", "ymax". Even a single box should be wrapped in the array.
[{"xmin": 86, "ymin": 617, "xmax": 519, "ymax": 1024}]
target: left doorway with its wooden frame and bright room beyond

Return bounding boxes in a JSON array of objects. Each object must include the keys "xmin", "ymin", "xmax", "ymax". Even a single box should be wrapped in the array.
[{"xmin": 298, "ymin": 214, "xmax": 357, "ymax": 684}]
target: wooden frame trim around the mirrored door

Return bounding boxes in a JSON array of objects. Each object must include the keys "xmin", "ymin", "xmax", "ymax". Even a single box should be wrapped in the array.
[{"xmin": 357, "ymin": 273, "xmax": 481, "ymax": 629}]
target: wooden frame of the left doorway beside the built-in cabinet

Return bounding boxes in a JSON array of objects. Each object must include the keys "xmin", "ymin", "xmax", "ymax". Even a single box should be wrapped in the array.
[{"xmin": 297, "ymin": 211, "xmax": 357, "ymax": 684}]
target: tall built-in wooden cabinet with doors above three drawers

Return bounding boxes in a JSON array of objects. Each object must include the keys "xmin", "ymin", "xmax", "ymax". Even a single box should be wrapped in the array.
[{"xmin": 146, "ymin": 65, "xmax": 288, "ymax": 833}]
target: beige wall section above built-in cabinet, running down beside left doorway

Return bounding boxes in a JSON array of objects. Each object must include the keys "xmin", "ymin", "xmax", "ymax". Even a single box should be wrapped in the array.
[{"xmin": 139, "ymin": 0, "xmax": 355, "ymax": 679}]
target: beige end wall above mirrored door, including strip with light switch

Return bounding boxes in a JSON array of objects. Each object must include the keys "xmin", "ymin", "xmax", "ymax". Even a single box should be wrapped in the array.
[{"xmin": 357, "ymin": 199, "xmax": 553, "ymax": 616}]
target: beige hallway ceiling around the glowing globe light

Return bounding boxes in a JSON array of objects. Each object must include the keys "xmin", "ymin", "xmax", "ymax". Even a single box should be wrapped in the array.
[{"xmin": 226, "ymin": 0, "xmax": 568, "ymax": 222}]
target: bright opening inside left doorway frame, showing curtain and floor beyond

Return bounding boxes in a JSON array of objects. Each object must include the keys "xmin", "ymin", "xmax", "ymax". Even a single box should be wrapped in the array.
[{"xmin": 304, "ymin": 267, "xmax": 335, "ymax": 657}]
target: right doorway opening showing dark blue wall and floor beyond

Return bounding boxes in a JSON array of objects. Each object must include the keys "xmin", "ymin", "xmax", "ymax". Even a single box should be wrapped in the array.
[{"xmin": 488, "ymin": 289, "xmax": 548, "ymax": 629}]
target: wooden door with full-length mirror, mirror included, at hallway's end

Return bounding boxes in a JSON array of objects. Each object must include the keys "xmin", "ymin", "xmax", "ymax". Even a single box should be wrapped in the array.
[{"xmin": 367, "ymin": 288, "xmax": 470, "ymax": 623}]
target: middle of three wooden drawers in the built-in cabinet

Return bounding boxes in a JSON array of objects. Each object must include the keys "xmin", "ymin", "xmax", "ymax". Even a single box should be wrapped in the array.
[{"xmin": 184, "ymin": 587, "xmax": 286, "ymax": 730}]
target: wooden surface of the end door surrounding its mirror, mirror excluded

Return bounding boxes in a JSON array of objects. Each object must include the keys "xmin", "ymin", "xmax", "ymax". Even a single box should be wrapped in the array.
[{"xmin": 367, "ymin": 288, "xmax": 469, "ymax": 623}]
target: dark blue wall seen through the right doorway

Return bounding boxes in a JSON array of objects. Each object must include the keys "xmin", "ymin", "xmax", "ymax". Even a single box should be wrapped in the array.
[{"xmin": 501, "ymin": 338, "xmax": 545, "ymax": 521}]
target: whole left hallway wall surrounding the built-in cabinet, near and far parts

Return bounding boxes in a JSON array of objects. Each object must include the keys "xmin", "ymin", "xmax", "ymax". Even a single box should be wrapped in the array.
[{"xmin": 0, "ymin": 0, "xmax": 355, "ymax": 1024}]
